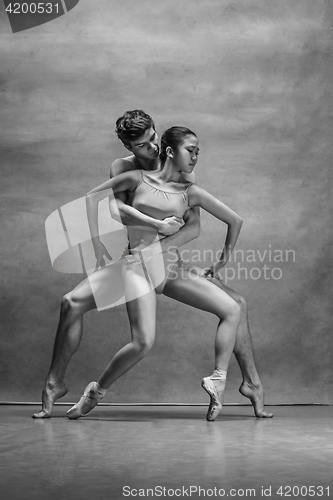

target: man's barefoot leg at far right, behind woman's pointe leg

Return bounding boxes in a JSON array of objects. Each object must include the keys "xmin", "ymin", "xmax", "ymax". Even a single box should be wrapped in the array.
[{"xmin": 207, "ymin": 278, "xmax": 273, "ymax": 418}]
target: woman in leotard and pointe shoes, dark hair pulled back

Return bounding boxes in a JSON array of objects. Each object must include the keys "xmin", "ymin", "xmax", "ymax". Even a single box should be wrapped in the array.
[{"xmin": 67, "ymin": 127, "xmax": 242, "ymax": 421}]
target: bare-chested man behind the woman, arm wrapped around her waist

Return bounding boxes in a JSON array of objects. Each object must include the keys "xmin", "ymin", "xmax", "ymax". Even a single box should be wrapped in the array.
[{"xmin": 33, "ymin": 110, "xmax": 273, "ymax": 418}]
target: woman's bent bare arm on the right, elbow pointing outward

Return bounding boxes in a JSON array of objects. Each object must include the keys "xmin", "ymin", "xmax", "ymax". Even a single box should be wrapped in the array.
[{"xmin": 188, "ymin": 184, "xmax": 243, "ymax": 273}]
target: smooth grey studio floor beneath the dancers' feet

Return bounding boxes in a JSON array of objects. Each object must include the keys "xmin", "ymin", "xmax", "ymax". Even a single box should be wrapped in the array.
[{"xmin": 0, "ymin": 405, "xmax": 333, "ymax": 500}]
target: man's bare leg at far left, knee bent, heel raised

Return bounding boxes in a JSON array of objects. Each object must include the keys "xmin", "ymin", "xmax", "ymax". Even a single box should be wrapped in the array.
[{"xmin": 33, "ymin": 278, "xmax": 96, "ymax": 418}]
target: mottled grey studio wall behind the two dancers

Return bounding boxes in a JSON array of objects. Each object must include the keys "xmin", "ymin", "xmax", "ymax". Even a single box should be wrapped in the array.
[{"xmin": 0, "ymin": 0, "xmax": 333, "ymax": 404}]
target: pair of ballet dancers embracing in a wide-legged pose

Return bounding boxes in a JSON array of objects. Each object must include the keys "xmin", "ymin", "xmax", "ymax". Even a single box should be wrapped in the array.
[{"xmin": 34, "ymin": 110, "xmax": 272, "ymax": 420}]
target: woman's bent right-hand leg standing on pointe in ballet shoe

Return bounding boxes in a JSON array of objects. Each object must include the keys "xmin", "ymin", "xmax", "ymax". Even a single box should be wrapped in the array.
[{"xmin": 163, "ymin": 263, "xmax": 240, "ymax": 420}]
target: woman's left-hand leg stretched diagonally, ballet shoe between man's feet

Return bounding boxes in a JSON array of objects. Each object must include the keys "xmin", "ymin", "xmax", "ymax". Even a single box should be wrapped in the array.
[{"xmin": 67, "ymin": 266, "xmax": 156, "ymax": 419}]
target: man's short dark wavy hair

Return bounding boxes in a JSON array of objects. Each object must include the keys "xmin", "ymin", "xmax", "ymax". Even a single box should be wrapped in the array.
[{"xmin": 116, "ymin": 109, "xmax": 155, "ymax": 146}]
